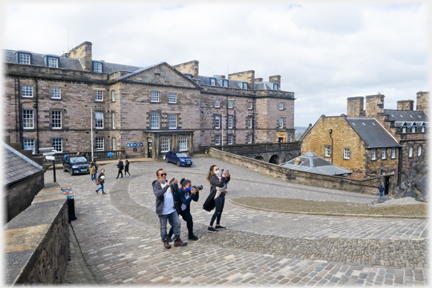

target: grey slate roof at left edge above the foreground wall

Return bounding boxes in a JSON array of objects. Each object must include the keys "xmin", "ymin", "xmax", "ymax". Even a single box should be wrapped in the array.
[{"xmin": 3, "ymin": 143, "xmax": 43, "ymax": 185}]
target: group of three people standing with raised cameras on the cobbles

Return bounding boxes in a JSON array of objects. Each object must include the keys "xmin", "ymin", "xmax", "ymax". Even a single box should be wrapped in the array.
[{"xmin": 152, "ymin": 165, "xmax": 230, "ymax": 249}]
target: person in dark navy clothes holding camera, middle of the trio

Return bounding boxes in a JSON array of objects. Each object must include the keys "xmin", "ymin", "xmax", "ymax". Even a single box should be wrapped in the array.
[{"xmin": 168, "ymin": 178, "xmax": 199, "ymax": 240}]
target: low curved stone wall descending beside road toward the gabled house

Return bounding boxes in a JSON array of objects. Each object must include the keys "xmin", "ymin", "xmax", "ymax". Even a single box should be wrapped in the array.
[{"xmin": 209, "ymin": 148, "xmax": 382, "ymax": 195}]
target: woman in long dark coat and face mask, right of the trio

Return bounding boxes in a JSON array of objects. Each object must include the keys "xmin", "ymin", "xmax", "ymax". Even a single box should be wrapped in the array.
[{"xmin": 203, "ymin": 165, "xmax": 230, "ymax": 232}]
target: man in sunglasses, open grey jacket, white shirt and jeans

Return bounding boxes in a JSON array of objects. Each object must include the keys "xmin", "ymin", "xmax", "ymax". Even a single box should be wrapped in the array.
[{"xmin": 152, "ymin": 169, "xmax": 187, "ymax": 249}]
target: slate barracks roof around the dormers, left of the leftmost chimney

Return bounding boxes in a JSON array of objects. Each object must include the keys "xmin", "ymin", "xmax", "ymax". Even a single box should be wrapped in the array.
[{"xmin": 3, "ymin": 49, "xmax": 83, "ymax": 71}]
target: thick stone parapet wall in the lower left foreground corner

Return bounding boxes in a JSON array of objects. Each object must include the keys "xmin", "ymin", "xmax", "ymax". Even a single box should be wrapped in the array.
[{"xmin": 3, "ymin": 183, "xmax": 69, "ymax": 285}]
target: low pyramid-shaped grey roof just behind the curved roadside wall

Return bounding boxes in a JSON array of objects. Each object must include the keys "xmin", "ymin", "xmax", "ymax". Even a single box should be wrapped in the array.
[{"xmin": 281, "ymin": 150, "xmax": 351, "ymax": 176}]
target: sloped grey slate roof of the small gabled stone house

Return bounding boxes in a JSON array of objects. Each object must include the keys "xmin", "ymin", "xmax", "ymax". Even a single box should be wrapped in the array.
[{"xmin": 346, "ymin": 118, "xmax": 401, "ymax": 148}]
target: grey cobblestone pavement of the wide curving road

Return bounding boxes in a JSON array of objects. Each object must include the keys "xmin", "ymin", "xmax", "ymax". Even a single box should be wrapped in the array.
[{"xmin": 58, "ymin": 157, "xmax": 428, "ymax": 286}]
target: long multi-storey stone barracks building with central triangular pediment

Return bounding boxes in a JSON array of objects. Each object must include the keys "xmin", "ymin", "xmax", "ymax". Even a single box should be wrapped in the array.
[{"xmin": 4, "ymin": 42, "xmax": 295, "ymax": 159}]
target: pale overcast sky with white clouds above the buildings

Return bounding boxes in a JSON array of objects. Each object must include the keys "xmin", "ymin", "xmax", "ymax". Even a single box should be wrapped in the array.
[{"xmin": 3, "ymin": 1, "xmax": 430, "ymax": 126}]
